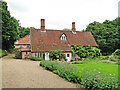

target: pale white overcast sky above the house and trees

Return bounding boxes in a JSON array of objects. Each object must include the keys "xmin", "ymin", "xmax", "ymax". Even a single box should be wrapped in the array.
[{"xmin": 5, "ymin": 0, "xmax": 119, "ymax": 31}]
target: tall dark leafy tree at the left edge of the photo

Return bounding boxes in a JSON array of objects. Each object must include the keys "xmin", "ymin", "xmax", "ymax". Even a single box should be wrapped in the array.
[{"xmin": 0, "ymin": 1, "xmax": 19, "ymax": 50}]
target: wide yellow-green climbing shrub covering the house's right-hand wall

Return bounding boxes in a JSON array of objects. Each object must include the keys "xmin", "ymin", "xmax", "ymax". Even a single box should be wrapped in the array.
[{"xmin": 72, "ymin": 45, "xmax": 101, "ymax": 58}]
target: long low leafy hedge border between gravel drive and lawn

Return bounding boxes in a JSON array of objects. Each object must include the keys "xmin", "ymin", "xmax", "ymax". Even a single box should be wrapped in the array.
[{"xmin": 40, "ymin": 61, "xmax": 118, "ymax": 89}]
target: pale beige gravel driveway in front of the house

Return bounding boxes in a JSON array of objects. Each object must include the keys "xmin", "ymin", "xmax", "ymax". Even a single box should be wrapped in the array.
[{"xmin": 2, "ymin": 54, "xmax": 76, "ymax": 88}]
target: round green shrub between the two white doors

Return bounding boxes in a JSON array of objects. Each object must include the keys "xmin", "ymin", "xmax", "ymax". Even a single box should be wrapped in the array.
[{"xmin": 49, "ymin": 50, "xmax": 65, "ymax": 60}]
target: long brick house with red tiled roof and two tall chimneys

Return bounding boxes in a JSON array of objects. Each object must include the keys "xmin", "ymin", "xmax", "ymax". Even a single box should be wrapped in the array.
[{"xmin": 14, "ymin": 19, "xmax": 97, "ymax": 61}]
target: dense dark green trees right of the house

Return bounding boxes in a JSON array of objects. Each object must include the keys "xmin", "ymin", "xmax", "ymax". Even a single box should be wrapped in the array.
[{"xmin": 84, "ymin": 18, "xmax": 120, "ymax": 55}]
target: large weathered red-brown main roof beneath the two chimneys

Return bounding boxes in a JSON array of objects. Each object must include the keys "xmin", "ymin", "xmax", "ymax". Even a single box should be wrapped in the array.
[{"xmin": 30, "ymin": 29, "xmax": 97, "ymax": 52}]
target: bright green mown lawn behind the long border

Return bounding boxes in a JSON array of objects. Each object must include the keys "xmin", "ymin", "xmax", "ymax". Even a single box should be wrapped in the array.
[{"xmin": 71, "ymin": 63, "xmax": 118, "ymax": 77}]
